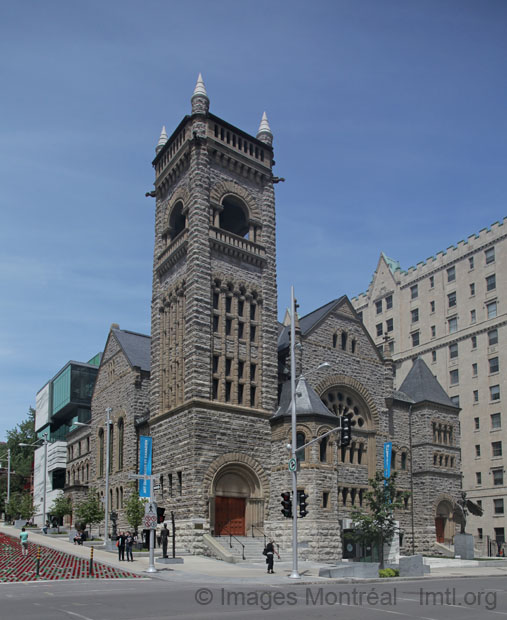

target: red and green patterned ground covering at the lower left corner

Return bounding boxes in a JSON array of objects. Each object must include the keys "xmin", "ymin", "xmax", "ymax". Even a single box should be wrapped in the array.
[{"xmin": 0, "ymin": 533, "xmax": 140, "ymax": 582}]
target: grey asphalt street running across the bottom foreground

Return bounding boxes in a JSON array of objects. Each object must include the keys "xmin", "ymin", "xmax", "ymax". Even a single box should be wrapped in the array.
[{"xmin": 0, "ymin": 577, "xmax": 507, "ymax": 620}]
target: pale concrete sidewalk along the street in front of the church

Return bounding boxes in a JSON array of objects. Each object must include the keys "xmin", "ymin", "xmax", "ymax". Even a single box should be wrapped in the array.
[{"xmin": 0, "ymin": 525, "xmax": 507, "ymax": 586}]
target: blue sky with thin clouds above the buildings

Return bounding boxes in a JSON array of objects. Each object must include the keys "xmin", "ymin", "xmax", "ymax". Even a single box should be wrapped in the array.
[{"xmin": 0, "ymin": 0, "xmax": 507, "ymax": 440}]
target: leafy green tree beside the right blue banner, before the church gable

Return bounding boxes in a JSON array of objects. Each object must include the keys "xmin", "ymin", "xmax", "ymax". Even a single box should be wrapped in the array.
[{"xmin": 351, "ymin": 471, "xmax": 410, "ymax": 569}]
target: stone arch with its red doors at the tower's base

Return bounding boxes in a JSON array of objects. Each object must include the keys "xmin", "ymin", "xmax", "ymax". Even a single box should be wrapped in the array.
[{"xmin": 203, "ymin": 452, "xmax": 269, "ymax": 536}]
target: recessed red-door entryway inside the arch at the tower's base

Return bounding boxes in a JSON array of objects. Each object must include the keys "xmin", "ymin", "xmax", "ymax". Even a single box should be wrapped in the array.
[{"xmin": 210, "ymin": 463, "xmax": 264, "ymax": 536}]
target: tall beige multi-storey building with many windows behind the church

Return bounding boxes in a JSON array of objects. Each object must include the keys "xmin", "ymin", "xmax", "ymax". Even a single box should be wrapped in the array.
[{"xmin": 352, "ymin": 219, "xmax": 507, "ymax": 550}]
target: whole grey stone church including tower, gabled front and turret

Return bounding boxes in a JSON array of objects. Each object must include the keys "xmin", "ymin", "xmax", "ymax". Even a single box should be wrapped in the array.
[{"xmin": 91, "ymin": 76, "xmax": 460, "ymax": 560}]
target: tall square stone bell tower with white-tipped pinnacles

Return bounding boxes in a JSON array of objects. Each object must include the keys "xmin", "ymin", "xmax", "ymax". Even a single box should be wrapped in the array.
[{"xmin": 150, "ymin": 75, "xmax": 277, "ymax": 551}]
